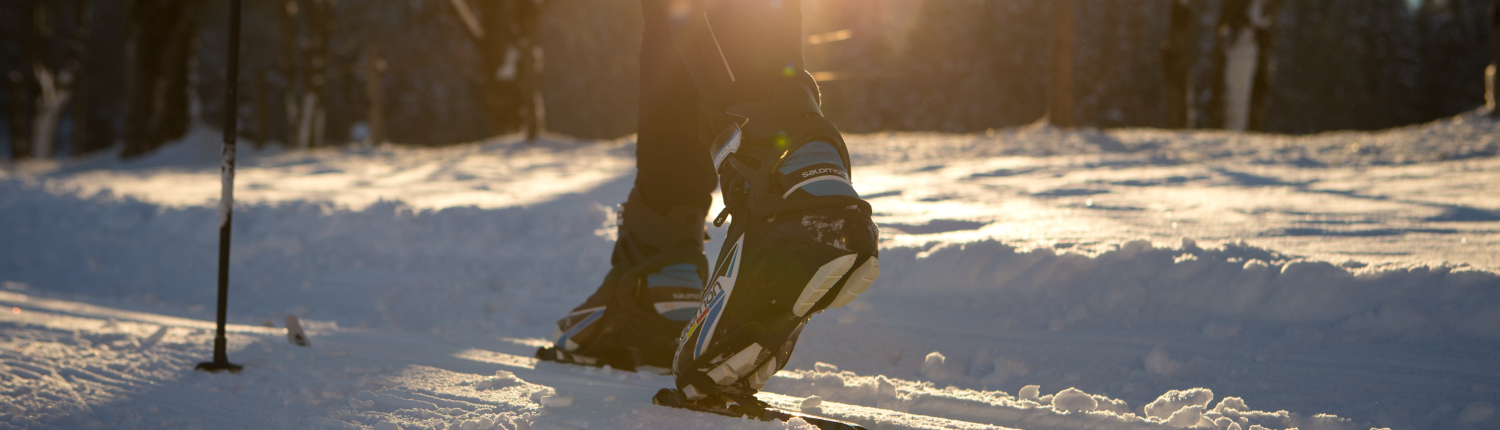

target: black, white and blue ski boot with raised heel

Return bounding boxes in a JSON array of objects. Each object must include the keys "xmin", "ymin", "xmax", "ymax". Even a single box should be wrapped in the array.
[{"xmin": 672, "ymin": 79, "xmax": 881, "ymax": 401}]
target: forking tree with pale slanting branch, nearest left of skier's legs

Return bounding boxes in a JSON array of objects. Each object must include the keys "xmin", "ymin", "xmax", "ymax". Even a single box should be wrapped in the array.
[{"xmin": 449, "ymin": 0, "xmax": 546, "ymax": 141}]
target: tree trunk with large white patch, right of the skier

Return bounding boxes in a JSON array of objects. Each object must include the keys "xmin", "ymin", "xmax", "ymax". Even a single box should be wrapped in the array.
[{"xmin": 1209, "ymin": 0, "xmax": 1283, "ymax": 130}]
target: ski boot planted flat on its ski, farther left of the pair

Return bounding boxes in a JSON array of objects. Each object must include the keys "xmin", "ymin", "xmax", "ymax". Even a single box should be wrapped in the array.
[{"xmin": 537, "ymin": 190, "xmax": 708, "ymax": 373}]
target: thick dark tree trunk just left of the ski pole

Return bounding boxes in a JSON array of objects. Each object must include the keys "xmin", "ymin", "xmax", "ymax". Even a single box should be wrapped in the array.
[{"xmin": 120, "ymin": 0, "xmax": 200, "ymax": 159}]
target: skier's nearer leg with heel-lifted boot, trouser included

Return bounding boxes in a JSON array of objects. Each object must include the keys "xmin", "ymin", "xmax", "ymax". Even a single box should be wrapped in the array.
[{"xmin": 647, "ymin": 0, "xmax": 879, "ymax": 403}]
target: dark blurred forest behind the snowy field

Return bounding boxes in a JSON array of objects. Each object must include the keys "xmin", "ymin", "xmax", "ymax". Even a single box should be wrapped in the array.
[{"xmin": 0, "ymin": 0, "xmax": 1500, "ymax": 160}]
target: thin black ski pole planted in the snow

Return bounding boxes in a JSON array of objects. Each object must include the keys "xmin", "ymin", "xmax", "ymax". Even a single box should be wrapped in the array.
[{"xmin": 195, "ymin": 0, "xmax": 245, "ymax": 373}]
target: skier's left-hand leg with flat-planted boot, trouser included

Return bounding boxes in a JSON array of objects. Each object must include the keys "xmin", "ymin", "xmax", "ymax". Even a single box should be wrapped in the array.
[{"xmin": 537, "ymin": 0, "xmax": 717, "ymax": 370}]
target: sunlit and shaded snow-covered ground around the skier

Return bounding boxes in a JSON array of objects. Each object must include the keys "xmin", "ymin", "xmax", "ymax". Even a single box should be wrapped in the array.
[{"xmin": 0, "ymin": 112, "xmax": 1500, "ymax": 430}]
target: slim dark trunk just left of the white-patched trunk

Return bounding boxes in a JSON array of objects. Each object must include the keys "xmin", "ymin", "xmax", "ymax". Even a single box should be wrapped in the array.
[{"xmin": 1161, "ymin": 0, "xmax": 1197, "ymax": 129}]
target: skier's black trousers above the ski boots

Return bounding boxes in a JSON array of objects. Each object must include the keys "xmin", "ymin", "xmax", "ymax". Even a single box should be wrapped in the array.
[{"xmin": 636, "ymin": 0, "xmax": 818, "ymax": 213}]
